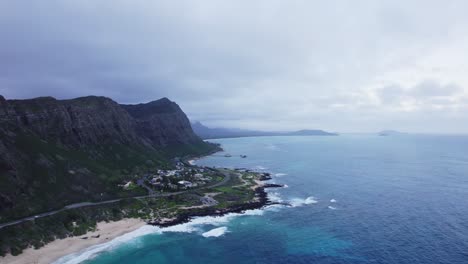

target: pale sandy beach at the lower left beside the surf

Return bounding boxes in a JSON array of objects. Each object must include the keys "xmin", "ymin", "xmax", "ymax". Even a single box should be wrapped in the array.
[{"xmin": 0, "ymin": 219, "xmax": 146, "ymax": 264}]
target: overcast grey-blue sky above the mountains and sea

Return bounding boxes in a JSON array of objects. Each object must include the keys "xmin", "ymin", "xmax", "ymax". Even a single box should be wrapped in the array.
[{"xmin": 0, "ymin": 0, "xmax": 468, "ymax": 133}]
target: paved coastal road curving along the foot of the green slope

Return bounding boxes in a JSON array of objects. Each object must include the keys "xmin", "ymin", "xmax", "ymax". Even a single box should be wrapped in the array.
[{"xmin": 0, "ymin": 170, "xmax": 231, "ymax": 229}]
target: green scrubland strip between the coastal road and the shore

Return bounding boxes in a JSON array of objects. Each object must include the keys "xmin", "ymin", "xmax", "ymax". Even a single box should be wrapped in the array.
[{"xmin": 0, "ymin": 170, "xmax": 260, "ymax": 255}]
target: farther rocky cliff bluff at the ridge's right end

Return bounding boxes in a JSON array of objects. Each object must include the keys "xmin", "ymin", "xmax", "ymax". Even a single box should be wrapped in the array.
[{"xmin": 122, "ymin": 98, "xmax": 200, "ymax": 146}]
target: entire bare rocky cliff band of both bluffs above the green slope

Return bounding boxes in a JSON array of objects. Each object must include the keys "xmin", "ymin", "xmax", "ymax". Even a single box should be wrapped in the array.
[{"xmin": 0, "ymin": 96, "xmax": 200, "ymax": 151}]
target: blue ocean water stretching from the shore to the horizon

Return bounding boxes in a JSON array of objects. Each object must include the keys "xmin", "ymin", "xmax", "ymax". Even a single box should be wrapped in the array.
[{"xmin": 60, "ymin": 135, "xmax": 468, "ymax": 264}]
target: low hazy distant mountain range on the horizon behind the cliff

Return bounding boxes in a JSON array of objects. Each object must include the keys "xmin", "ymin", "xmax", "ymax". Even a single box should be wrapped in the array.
[{"xmin": 192, "ymin": 122, "xmax": 338, "ymax": 139}]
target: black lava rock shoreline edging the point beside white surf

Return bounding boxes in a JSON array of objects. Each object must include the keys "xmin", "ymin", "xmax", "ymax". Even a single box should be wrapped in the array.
[{"xmin": 148, "ymin": 173, "xmax": 284, "ymax": 227}]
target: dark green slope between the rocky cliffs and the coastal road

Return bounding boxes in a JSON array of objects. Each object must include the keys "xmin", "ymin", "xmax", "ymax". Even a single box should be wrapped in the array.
[{"xmin": 0, "ymin": 131, "xmax": 213, "ymax": 222}]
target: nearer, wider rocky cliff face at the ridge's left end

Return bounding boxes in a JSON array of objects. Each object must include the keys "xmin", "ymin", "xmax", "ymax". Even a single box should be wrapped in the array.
[{"xmin": 0, "ymin": 96, "xmax": 142, "ymax": 147}]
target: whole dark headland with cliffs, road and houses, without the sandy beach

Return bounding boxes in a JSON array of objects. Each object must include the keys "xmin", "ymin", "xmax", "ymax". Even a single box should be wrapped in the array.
[{"xmin": 0, "ymin": 96, "xmax": 281, "ymax": 256}]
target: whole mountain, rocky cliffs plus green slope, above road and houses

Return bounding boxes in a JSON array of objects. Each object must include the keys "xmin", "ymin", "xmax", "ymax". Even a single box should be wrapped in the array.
[{"xmin": 0, "ymin": 96, "xmax": 214, "ymax": 222}]
